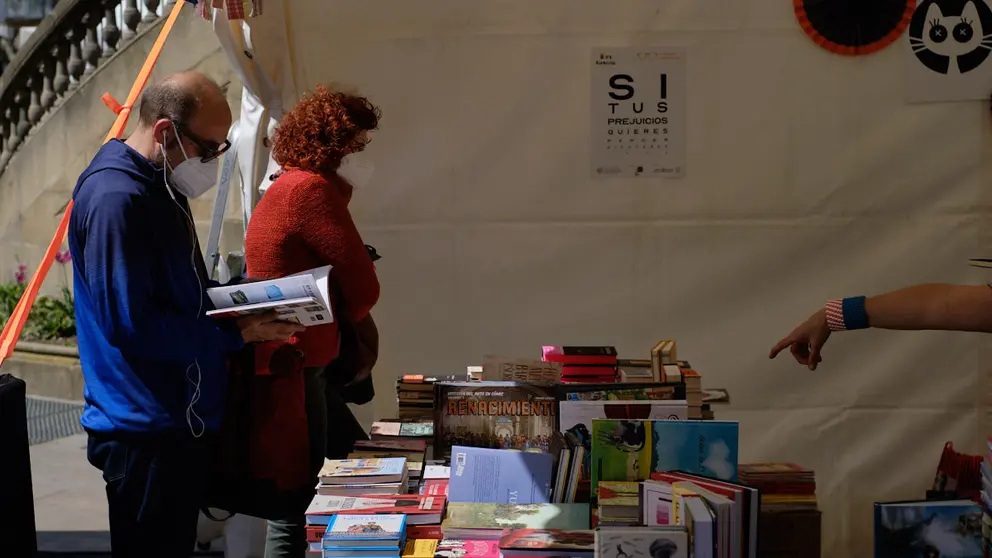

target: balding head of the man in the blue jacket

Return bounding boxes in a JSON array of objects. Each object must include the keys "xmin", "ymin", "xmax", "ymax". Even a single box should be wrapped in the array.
[{"xmin": 128, "ymin": 72, "xmax": 231, "ymax": 166}]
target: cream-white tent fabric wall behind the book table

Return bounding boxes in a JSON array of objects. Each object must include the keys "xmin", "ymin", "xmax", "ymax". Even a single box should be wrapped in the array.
[{"xmin": 209, "ymin": 0, "xmax": 992, "ymax": 558}]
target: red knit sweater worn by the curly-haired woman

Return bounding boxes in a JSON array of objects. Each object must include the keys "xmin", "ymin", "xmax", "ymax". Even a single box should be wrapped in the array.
[{"xmin": 245, "ymin": 170, "xmax": 379, "ymax": 367}]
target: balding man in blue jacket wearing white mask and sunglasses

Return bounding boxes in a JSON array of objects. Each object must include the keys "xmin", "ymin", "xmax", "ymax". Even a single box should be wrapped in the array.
[{"xmin": 69, "ymin": 72, "xmax": 302, "ymax": 558}]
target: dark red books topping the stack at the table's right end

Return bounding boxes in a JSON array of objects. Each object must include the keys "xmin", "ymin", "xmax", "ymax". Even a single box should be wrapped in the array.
[{"xmin": 737, "ymin": 463, "xmax": 817, "ymax": 510}]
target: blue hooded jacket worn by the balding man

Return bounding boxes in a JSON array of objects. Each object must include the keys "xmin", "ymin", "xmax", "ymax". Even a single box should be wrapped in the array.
[{"xmin": 69, "ymin": 140, "xmax": 244, "ymax": 433}]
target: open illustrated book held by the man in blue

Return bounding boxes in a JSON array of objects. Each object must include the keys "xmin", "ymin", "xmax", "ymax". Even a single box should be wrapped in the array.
[{"xmin": 207, "ymin": 265, "xmax": 334, "ymax": 326}]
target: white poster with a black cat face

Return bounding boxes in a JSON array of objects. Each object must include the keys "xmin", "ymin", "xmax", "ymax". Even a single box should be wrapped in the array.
[{"xmin": 901, "ymin": 0, "xmax": 992, "ymax": 103}]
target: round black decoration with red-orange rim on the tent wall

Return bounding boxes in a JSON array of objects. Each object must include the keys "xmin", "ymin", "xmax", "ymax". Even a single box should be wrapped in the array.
[{"xmin": 792, "ymin": 0, "xmax": 916, "ymax": 56}]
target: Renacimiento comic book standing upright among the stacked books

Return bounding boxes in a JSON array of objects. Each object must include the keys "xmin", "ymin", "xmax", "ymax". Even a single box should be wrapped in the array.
[{"xmin": 434, "ymin": 382, "xmax": 558, "ymax": 459}]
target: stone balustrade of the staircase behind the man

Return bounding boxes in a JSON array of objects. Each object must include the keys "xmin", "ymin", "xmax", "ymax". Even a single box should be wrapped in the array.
[{"xmin": 0, "ymin": 0, "xmax": 181, "ymax": 173}]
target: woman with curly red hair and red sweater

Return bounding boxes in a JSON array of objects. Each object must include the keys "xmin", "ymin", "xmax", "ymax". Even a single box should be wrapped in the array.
[{"xmin": 245, "ymin": 86, "xmax": 380, "ymax": 558}]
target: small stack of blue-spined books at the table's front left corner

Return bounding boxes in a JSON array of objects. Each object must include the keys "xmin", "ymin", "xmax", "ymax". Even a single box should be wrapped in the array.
[{"xmin": 322, "ymin": 514, "xmax": 406, "ymax": 558}]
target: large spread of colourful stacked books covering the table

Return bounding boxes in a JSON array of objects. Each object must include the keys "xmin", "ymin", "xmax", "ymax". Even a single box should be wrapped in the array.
[{"xmin": 298, "ymin": 341, "xmax": 756, "ymax": 558}]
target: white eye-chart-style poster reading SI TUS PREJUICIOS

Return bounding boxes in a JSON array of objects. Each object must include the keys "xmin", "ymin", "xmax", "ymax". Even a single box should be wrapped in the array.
[{"xmin": 590, "ymin": 47, "xmax": 686, "ymax": 179}]
